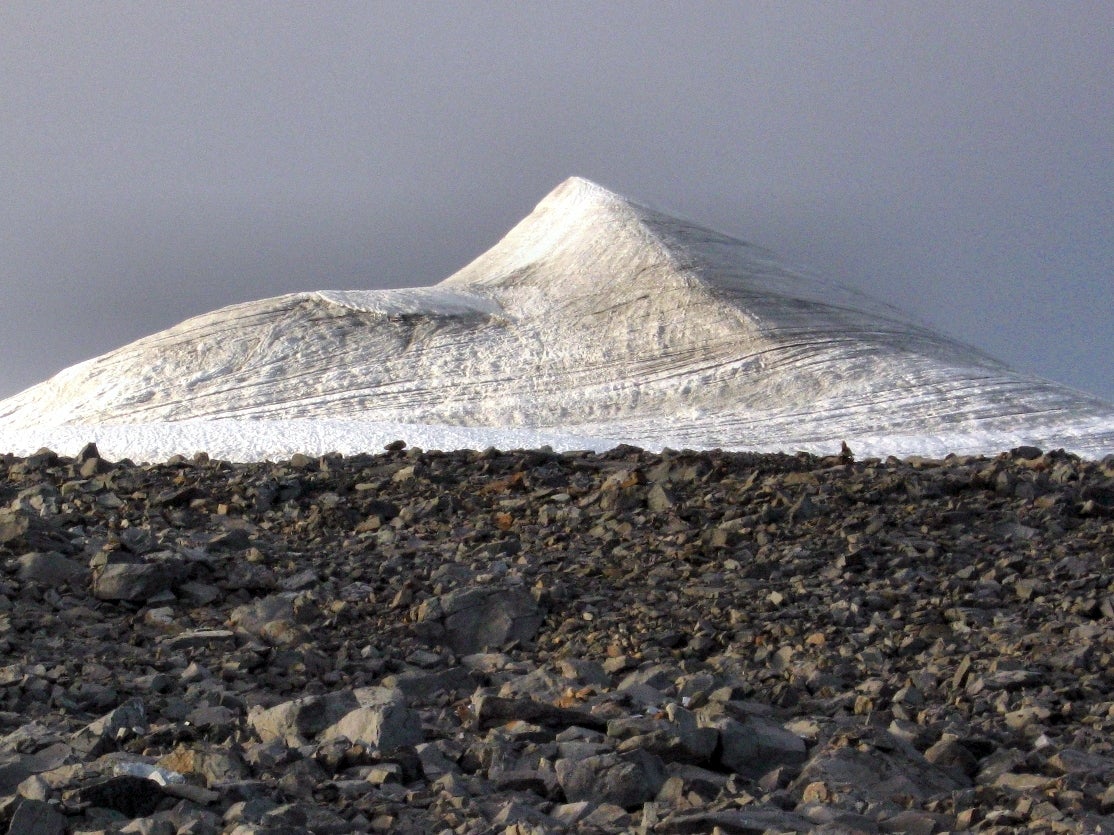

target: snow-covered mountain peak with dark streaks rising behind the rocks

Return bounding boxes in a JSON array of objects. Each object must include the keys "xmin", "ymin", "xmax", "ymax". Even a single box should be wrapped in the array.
[{"xmin": 0, "ymin": 178, "xmax": 1114, "ymax": 465}]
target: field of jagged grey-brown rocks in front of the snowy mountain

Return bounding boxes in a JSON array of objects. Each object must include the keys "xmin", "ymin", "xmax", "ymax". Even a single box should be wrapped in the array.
[{"xmin": 0, "ymin": 444, "xmax": 1114, "ymax": 835}]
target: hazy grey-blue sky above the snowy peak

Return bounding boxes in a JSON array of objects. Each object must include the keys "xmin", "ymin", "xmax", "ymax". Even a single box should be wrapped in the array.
[{"xmin": 0, "ymin": 0, "xmax": 1114, "ymax": 400}]
